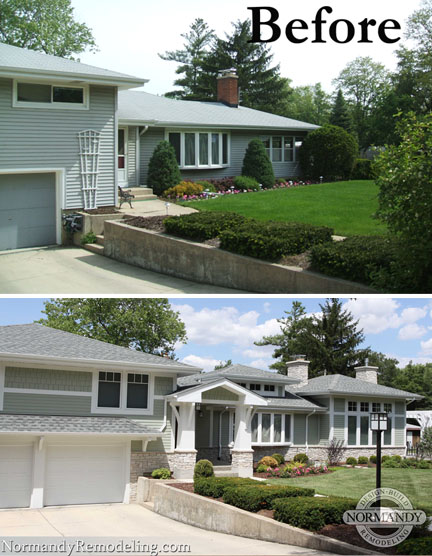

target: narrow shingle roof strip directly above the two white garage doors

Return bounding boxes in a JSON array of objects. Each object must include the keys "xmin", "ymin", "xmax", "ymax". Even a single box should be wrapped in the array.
[{"xmin": 0, "ymin": 414, "xmax": 160, "ymax": 436}]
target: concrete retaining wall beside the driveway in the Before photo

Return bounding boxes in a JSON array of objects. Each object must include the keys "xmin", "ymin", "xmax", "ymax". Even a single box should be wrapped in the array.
[{"xmin": 104, "ymin": 221, "xmax": 376, "ymax": 294}]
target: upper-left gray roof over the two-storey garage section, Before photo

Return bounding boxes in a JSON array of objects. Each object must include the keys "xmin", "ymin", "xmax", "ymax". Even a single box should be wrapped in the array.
[{"xmin": 0, "ymin": 43, "xmax": 148, "ymax": 87}]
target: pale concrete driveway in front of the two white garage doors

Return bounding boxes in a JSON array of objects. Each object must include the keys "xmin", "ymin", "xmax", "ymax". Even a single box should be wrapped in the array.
[{"xmin": 0, "ymin": 504, "xmax": 332, "ymax": 556}]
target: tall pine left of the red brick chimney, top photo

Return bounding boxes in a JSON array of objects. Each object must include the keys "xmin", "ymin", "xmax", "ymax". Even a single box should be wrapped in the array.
[{"xmin": 159, "ymin": 18, "xmax": 215, "ymax": 100}]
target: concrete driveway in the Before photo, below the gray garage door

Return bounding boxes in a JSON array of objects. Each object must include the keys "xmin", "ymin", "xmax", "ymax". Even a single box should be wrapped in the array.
[{"xmin": 0, "ymin": 247, "xmax": 243, "ymax": 295}]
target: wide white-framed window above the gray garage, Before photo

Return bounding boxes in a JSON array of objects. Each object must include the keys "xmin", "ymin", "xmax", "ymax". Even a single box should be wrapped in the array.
[{"xmin": 14, "ymin": 82, "xmax": 88, "ymax": 108}]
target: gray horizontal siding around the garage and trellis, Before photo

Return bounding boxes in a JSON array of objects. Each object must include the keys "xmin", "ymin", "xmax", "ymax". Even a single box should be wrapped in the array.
[{"xmin": 0, "ymin": 79, "xmax": 117, "ymax": 209}]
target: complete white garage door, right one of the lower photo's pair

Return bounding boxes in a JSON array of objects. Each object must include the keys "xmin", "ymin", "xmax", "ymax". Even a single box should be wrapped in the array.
[{"xmin": 44, "ymin": 444, "xmax": 126, "ymax": 506}]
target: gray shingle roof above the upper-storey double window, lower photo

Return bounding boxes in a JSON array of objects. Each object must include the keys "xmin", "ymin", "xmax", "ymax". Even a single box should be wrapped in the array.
[{"xmin": 0, "ymin": 324, "xmax": 198, "ymax": 372}]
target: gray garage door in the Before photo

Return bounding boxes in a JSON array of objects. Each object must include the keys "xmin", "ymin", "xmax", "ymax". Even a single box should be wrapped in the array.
[{"xmin": 0, "ymin": 172, "xmax": 56, "ymax": 251}]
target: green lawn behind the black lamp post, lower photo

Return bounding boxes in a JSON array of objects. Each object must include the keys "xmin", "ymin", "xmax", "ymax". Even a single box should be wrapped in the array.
[{"xmin": 269, "ymin": 468, "xmax": 432, "ymax": 515}]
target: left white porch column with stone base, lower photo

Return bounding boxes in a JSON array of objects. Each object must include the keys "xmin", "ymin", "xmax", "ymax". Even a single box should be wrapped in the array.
[{"xmin": 173, "ymin": 402, "xmax": 197, "ymax": 479}]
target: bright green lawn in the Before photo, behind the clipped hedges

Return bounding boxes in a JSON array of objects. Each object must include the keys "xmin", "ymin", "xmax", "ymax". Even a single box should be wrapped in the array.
[{"xmin": 182, "ymin": 181, "xmax": 385, "ymax": 236}]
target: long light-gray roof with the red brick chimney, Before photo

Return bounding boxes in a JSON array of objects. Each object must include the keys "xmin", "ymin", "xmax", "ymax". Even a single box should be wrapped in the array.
[{"xmin": 118, "ymin": 91, "xmax": 319, "ymax": 131}]
